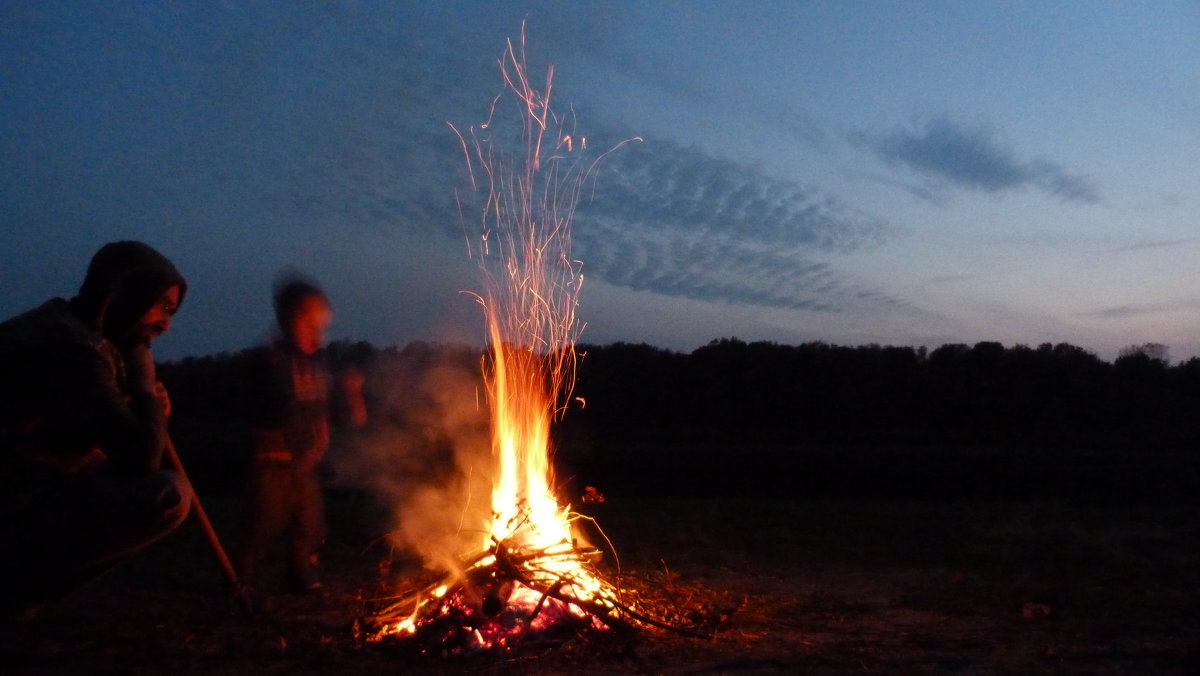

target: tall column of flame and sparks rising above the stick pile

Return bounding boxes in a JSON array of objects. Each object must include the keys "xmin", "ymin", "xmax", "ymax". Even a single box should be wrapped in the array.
[{"xmin": 468, "ymin": 26, "xmax": 583, "ymax": 561}]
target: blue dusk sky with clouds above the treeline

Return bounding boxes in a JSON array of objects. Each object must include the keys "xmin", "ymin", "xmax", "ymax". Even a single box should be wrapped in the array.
[{"xmin": 0, "ymin": 0, "xmax": 1200, "ymax": 361}]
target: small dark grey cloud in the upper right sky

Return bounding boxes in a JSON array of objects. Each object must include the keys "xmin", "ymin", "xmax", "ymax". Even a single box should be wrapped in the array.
[{"xmin": 854, "ymin": 118, "xmax": 1100, "ymax": 204}]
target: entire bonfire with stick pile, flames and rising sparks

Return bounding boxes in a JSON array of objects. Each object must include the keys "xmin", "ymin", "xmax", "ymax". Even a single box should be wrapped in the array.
[{"xmin": 359, "ymin": 26, "xmax": 721, "ymax": 654}]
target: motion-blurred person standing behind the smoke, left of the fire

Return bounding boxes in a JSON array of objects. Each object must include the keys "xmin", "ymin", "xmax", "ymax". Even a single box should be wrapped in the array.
[{"xmin": 239, "ymin": 273, "xmax": 366, "ymax": 593}]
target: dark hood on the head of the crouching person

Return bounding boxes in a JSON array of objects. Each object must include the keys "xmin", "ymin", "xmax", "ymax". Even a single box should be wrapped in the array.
[{"xmin": 71, "ymin": 241, "xmax": 187, "ymax": 343}]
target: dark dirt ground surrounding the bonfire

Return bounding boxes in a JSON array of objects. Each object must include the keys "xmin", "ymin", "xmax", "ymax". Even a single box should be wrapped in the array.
[{"xmin": 0, "ymin": 498, "xmax": 1200, "ymax": 675}]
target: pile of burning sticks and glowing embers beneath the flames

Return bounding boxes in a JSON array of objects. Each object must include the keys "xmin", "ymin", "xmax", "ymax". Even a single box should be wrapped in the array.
[{"xmin": 356, "ymin": 542, "xmax": 733, "ymax": 656}]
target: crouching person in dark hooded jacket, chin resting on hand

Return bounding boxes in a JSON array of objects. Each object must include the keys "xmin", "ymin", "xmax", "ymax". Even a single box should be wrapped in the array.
[{"xmin": 0, "ymin": 241, "xmax": 192, "ymax": 620}]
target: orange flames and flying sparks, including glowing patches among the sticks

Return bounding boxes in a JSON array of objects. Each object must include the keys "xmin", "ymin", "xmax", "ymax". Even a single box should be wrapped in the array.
[{"xmin": 372, "ymin": 24, "xmax": 641, "ymax": 645}]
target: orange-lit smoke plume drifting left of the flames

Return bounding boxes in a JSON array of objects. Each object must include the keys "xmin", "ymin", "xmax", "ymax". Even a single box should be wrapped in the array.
[{"xmin": 330, "ymin": 343, "xmax": 494, "ymax": 570}]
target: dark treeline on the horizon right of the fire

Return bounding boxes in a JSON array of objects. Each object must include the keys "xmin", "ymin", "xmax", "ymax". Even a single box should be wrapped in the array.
[{"xmin": 564, "ymin": 340, "xmax": 1200, "ymax": 448}]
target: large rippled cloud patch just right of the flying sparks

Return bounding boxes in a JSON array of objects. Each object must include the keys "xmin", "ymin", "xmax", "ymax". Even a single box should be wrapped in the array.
[{"xmin": 574, "ymin": 135, "xmax": 902, "ymax": 311}]
